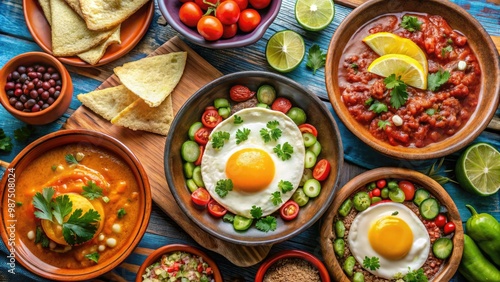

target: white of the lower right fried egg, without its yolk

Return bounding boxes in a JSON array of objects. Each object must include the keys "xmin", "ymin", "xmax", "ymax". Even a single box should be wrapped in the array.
[{"xmin": 347, "ymin": 203, "xmax": 430, "ymax": 279}]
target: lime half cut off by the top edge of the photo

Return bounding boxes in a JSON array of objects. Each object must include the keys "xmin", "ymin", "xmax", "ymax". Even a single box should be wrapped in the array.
[{"xmin": 295, "ymin": 0, "xmax": 335, "ymax": 31}]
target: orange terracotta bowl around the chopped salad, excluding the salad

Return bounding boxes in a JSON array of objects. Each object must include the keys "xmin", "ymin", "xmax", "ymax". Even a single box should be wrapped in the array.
[{"xmin": 135, "ymin": 244, "xmax": 223, "ymax": 282}]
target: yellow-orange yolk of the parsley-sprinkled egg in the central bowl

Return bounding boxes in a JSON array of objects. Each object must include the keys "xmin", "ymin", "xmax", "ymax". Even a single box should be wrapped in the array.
[{"xmin": 226, "ymin": 148, "xmax": 275, "ymax": 193}]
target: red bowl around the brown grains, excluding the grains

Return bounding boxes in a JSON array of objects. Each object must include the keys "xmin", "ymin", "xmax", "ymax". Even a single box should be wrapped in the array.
[{"xmin": 255, "ymin": 250, "xmax": 330, "ymax": 282}]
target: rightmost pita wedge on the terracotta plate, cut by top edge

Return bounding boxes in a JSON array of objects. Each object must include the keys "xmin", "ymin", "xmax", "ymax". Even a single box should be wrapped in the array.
[{"xmin": 79, "ymin": 0, "xmax": 149, "ymax": 30}]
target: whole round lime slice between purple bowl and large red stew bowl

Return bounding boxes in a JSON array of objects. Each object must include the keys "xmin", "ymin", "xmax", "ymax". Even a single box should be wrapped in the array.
[{"xmin": 266, "ymin": 30, "xmax": 306, "ymax": 72}]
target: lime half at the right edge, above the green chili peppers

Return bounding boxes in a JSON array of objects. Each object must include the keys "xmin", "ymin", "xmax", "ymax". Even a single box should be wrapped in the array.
[{"xmin": 455, "ymin": 143, "xmax": 500, "ymax": 196}]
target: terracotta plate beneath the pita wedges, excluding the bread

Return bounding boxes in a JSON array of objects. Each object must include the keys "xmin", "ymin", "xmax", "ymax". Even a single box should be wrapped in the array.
[{"xmin": 23, "ymin": 0, "xmax": 155, "ymax": 67}]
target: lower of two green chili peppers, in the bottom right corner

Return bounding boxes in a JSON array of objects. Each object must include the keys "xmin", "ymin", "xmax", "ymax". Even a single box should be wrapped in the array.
[{"xmin": 458, "ymin": 234, "xmax": 500, "ymax": 282}]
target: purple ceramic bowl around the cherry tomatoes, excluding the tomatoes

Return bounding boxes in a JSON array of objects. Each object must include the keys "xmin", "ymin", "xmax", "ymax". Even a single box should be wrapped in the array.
[{"xmin": 158, "ymin": 0, "xmax": 281, "ymax": 49}]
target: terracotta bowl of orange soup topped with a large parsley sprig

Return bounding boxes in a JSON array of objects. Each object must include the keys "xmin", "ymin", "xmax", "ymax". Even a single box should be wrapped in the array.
[{"xmin": 0, "ymin": 130, "xmax": 151, "ymax": 281}]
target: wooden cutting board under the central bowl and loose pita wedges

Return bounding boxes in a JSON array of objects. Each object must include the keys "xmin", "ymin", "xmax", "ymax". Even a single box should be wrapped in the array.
[{"xmin": 63, "ymin": 36, "xmax": 271, "ymax": 267}]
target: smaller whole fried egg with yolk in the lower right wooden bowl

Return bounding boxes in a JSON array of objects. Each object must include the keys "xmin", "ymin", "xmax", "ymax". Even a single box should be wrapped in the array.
[{"xmin": 347, "ymin": 203, "xmax": 430, "ymax": 279}]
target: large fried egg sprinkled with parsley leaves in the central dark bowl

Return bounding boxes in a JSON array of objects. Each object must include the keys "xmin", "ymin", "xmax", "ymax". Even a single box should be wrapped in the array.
[{"xmin": 201, "ymin": 107, "xmax": 305, "ymax": 218}]
